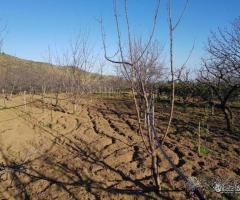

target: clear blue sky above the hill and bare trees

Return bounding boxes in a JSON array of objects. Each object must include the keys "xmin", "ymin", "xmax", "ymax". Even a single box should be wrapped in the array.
[{"xmin": 0, "ymin": 0, "xmax": 240, "ymax": 74}]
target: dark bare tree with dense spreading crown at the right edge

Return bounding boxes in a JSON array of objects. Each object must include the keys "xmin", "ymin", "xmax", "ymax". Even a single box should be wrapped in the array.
[{"xmin": 199, "ymin": 18, "xmax": 240, "ymax": 131}]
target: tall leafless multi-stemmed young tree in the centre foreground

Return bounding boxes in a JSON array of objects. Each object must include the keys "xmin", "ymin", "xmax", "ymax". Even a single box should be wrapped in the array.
[{"xmin": 100, "ymin": 0, "xmax": 202, "ymax": 197}]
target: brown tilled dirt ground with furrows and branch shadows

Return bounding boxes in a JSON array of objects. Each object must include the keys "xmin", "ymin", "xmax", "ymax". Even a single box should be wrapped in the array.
[{"xmin": 0, "ymin": 96, "xmax": 240, "ymax": 200}]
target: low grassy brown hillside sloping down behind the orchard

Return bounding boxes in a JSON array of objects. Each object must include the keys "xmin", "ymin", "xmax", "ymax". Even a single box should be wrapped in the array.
[{"xmin": 0, "ymin": 53, "xmax": 120, "ymax": 93}]
